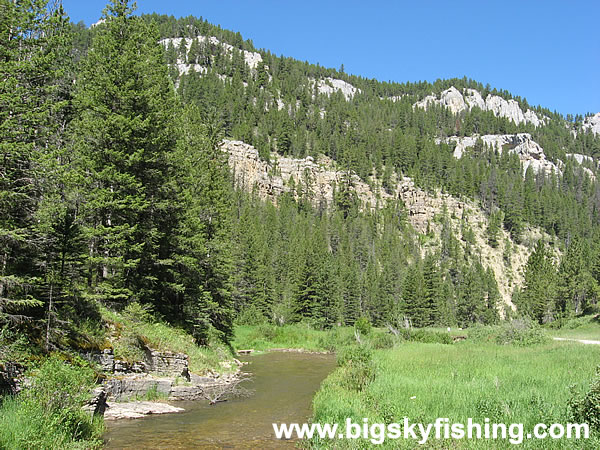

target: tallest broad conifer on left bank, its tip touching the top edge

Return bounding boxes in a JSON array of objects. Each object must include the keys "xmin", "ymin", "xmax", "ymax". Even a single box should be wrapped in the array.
[{"xmin": 74, "ymin": 0, "xmax": 176, "ymax": 310}]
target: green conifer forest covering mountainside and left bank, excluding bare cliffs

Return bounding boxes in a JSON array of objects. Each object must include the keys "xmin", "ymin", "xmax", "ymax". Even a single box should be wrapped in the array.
[{"xmin": 0, "ymin": 1, "xmax": 600, "ymax": 358}]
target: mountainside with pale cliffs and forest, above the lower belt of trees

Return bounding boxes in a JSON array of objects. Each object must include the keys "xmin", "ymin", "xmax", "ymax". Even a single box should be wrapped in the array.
[{"xmin": 129, "ymin": 16, "xmax": 600, "ymax": 320}]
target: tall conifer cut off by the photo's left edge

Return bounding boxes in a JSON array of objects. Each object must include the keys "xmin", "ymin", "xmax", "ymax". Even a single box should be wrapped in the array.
[{"xmin": 0, "ymin": 0, "xmax": 68, "ymax": 323}]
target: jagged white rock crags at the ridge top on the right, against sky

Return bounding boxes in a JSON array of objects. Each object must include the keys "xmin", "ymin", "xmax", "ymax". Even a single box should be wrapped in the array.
[{"xmin": 413, "ymin": 86, "xmax": 546, "ymax": 127}]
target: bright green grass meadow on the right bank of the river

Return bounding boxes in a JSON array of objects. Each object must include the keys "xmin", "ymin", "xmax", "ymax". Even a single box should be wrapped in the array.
[{"xmin": 311, "ymin": 341, "xmax": 600, "ymax": 449}]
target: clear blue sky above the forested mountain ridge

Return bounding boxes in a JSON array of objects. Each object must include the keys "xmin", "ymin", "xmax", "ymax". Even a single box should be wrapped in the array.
[{"xmin": 63, "ymin": 0, "xmax": 600, "ymax": 114}]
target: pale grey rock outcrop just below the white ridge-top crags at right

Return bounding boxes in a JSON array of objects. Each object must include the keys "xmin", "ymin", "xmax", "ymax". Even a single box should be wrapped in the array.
[{"xmin": 437, "ymin": 133, "xmax": 562, "ymax": 174}]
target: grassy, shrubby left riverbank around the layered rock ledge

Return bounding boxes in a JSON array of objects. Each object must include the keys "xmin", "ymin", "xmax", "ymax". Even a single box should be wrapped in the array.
[{"xmin": 0, "ymin": 303, "xmax": 238, "ymax": 449}]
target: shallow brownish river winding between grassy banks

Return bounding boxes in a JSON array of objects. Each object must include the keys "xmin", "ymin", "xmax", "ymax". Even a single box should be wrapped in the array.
[{"xmin": 105, "ymin": 352, "xmax": 335, "ymax": 449}]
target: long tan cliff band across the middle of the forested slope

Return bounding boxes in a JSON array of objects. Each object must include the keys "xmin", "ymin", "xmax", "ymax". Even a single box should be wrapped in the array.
[{"xmin": 222, "ymin": 140, "xmax": 535, "ymax": 308}]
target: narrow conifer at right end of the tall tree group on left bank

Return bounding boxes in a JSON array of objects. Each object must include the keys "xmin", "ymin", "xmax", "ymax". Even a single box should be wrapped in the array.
[{"xmin": 173, "ymin": 106, "xmax": 234, "ymax": 343}]
